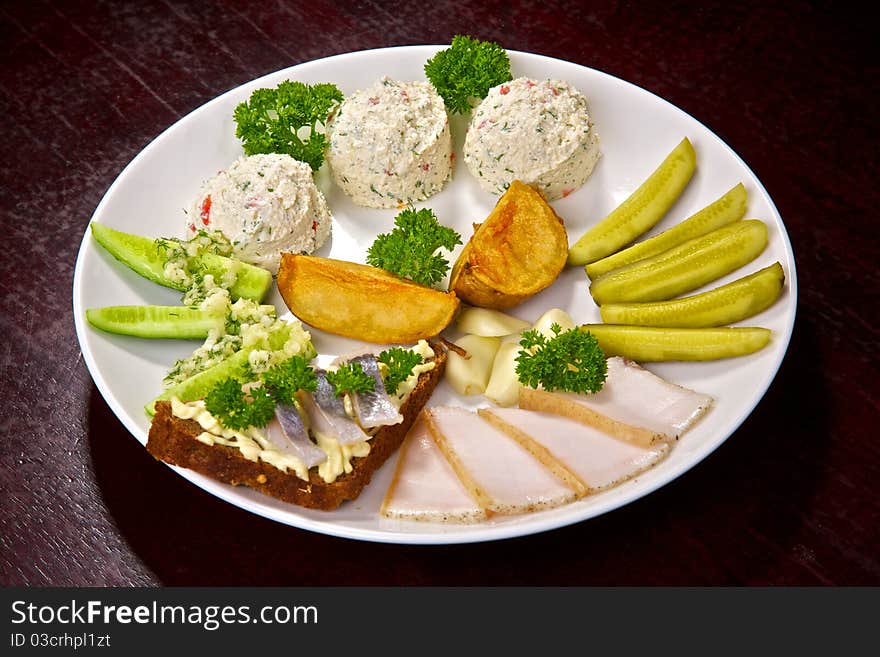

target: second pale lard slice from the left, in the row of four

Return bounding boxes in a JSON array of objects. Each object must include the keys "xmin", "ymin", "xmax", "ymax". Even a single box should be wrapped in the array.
[{"xmin": 425, "ymin": 406, "xmax": 577, "ymax": 514}]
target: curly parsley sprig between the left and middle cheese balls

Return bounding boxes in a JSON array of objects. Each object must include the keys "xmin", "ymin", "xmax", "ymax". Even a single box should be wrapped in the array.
[{"xmin": 233, "ymin": 80, "xmax": 343, "ymax": 171}]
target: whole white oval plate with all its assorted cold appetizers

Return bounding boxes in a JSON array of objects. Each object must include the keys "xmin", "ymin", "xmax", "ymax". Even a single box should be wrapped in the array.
[{"xmin": 73, "ymin": 42, "xmax": 797, "ymax": 543}]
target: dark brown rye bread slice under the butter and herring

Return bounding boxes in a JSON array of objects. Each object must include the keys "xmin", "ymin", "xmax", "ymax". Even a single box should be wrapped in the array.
[{"xmin": 147, "ymin": 344, "xmax": 446, "ymax": 511}]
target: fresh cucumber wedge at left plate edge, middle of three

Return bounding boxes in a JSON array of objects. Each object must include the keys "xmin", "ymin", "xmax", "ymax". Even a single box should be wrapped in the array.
[{"xmin": 86, "ymin": 306, "xmax": 226, "ymax": 340}]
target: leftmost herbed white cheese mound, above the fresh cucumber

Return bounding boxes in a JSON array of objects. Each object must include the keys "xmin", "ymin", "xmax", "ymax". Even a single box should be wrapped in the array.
[{"xmin": 186, "ymin": 154, "xmax": 332, "ymax": 274}]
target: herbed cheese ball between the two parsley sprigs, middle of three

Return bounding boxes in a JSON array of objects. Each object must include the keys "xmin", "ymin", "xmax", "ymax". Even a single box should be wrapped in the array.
[{"xmin": 327, "ymin": 77, "xmax": 452, "ymax": 208}]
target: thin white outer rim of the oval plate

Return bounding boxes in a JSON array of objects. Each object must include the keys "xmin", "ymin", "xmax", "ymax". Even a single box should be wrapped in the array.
[{"xmin": 72, "ymin": 44, "xmax": 798, "ymax": 545}]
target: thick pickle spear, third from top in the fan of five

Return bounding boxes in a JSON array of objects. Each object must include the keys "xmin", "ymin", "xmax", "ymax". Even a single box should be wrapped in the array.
[{"xmin": 590, "ymin": 219, "xmax": 767, "ymax": 306}]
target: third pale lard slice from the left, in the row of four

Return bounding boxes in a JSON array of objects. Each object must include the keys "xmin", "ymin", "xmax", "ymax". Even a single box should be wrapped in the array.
[{"xmin": 478, "ymin": 408, "xmax": 671, "ymax": 493}]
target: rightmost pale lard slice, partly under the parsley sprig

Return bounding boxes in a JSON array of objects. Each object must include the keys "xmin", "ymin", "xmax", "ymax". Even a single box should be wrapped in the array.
[{"xmin": 519, "ymin": 356, "xmax": 713, "ymax": 446}]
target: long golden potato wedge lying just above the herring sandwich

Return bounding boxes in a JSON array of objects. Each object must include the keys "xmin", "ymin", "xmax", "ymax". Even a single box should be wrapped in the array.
[{"xmin": 278, "ymin": 253, "xmax": 459, "ymax": 344}]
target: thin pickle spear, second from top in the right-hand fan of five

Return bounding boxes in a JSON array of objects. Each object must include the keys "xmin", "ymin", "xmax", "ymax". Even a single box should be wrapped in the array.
[{"xmin": 584, "ymin": 183, "xmax": 748, "ymax": 280}]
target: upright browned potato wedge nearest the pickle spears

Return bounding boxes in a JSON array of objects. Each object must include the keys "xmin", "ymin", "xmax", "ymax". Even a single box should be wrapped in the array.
[{"xmin": 449, "ymin": 180, "xmax": 568, "ymax": 310}]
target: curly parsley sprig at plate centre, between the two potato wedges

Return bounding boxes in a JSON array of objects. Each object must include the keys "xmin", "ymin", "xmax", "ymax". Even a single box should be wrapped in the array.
[{"xmin": 367, "ymin": 207, "xmax": 461, "ymax": 286}]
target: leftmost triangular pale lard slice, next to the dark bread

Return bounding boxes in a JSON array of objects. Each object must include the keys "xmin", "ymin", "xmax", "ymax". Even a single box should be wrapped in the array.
[{"xmin": 379, "ymin": 414, "xmax": 486, "ymax": 523}]
